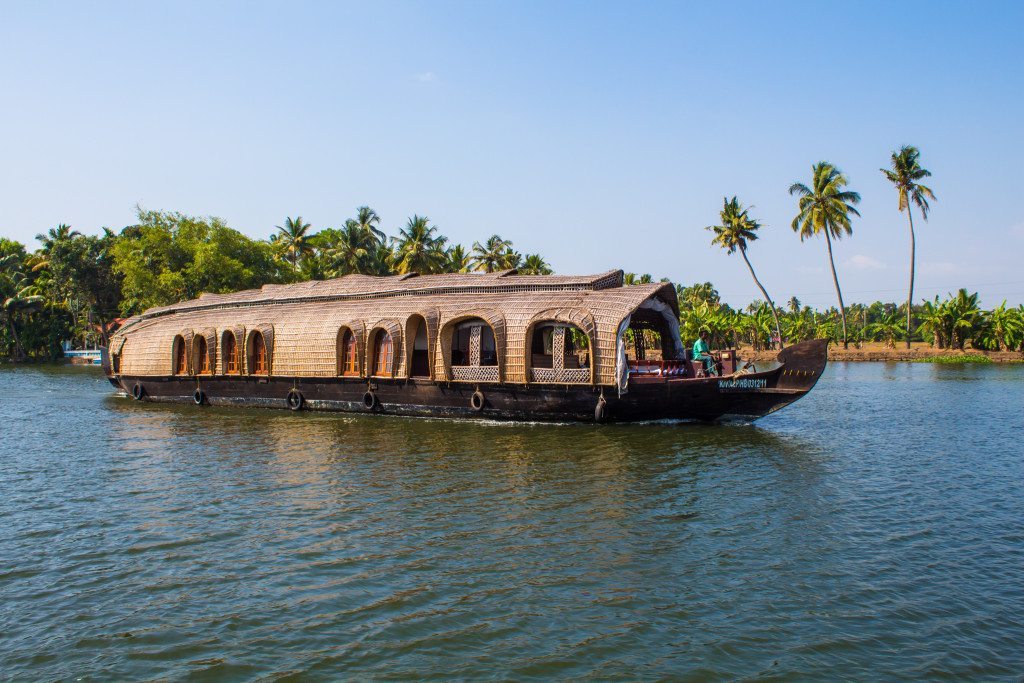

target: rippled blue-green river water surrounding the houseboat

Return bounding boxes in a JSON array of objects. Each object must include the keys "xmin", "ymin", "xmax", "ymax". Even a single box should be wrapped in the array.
[{"xmin": 0, "ymin": 364, "xmax": 1024, "ymax": 680}]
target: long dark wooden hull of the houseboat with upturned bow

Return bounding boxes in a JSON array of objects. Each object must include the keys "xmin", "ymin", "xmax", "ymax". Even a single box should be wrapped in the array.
[{"xmin": 108, "ymin": 340, "xmax": 826, "ymax": 422}]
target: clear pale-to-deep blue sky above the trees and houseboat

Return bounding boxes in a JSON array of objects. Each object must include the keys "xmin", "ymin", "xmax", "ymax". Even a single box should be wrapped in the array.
[{"xmin": 0, "ymin": 1, "xmax": 1024, "ymax": 307}]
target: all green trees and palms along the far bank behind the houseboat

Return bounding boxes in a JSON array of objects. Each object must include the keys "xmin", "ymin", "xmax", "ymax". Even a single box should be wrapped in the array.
[{"xmin": 0, "ymin": 142, "xmax": 1024, "ymax": 360}]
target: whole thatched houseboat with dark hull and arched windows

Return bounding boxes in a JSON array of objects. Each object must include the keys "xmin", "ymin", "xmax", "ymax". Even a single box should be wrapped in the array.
[{"xmin": 102, "ymin": 270, "xmax": 826, "ymax": 422}]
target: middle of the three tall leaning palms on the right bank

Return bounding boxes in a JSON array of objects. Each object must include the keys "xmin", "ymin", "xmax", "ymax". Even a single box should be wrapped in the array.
[{"xmin": 790, "ymin": 161, "xmax": 860, "ymax": 348}]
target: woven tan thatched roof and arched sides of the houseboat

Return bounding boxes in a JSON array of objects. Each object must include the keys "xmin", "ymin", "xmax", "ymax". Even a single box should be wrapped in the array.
[{"xmin": 111, "ymin": 270, "xmax": 678, "ymax": 385}]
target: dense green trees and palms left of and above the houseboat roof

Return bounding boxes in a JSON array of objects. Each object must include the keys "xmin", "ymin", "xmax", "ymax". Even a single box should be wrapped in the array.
[{"xmin": 0, "ymin": 207, "xmax": 553, "ymax": 360}]
